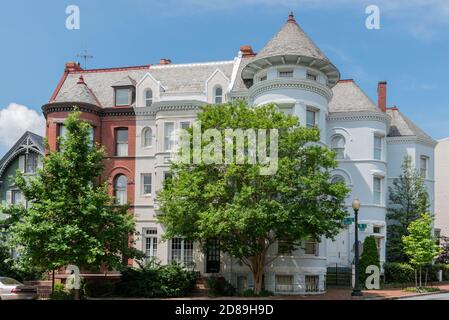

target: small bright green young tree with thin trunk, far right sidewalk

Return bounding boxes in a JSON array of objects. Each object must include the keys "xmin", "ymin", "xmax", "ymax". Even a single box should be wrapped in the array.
[{"xmin": 402, "ymin": 213, "xmax": 442, "ymax": 288}]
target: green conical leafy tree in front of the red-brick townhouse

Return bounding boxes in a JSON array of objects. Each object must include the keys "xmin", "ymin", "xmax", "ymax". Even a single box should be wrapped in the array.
[{"xmin": 4, "ymin": 111, "xmax": 134, "ymax": 278}]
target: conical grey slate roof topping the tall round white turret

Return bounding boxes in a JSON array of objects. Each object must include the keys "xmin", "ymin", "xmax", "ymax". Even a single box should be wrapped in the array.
[{"xmin": 257, "ymin": 20, "xmax": 329, "ymax": 61}]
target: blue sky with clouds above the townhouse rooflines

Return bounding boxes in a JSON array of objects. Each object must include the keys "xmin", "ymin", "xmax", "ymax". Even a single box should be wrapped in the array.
[{"xmin": 0, "ymin": 0, "xmax": 449, "ymax": 155}]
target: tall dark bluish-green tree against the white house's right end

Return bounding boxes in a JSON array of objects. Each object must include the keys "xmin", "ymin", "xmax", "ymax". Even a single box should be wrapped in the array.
[{"xmin": 386, "ymin": 156, "xmax": 429, "ymax": 262}]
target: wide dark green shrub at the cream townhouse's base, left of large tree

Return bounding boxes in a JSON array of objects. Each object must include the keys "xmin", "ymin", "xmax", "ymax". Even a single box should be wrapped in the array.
[{"xmin": 115, "ymin": 263, "xmax": 197, "ymax": 298}]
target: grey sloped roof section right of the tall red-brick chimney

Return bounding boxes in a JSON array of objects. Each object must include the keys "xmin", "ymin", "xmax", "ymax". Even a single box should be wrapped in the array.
[{"xmin": 387, "ymin": 107, "xmax": 436, "ymax": 143}]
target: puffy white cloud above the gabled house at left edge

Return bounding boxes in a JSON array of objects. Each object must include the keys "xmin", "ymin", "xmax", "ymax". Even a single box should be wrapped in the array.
[{"xmin": 0, "ymin": 103, "xmax": 45, "ymax": 150}]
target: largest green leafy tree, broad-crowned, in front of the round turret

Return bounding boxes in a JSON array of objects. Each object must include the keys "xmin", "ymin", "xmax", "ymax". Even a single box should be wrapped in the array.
[{"xmin": 158, "ymin": 102, "xmax": 348, "ymax": 294}]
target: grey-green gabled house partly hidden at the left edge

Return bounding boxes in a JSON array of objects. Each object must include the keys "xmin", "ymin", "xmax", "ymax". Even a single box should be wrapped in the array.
[{"xmin": 0, "ymin": 132, "xmax": 45, "ymax": 226}]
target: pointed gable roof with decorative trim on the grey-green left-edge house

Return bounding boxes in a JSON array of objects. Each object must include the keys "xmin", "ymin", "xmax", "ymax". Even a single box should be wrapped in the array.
[{"xmin": 0, "ymin": 131, "xmax": 45, "ymax": 177}]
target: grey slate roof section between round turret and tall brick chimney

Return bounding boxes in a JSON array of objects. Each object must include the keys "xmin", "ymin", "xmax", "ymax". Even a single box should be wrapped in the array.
[{"xmin": 329, "ymin": 79, "xmax": 381, "ymax": 113}]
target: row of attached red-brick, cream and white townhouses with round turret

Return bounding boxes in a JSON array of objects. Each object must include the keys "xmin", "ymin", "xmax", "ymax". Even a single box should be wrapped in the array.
[{"xmin": 43, "ymin": 15, "xmax": 435, "ymax": 294}]
